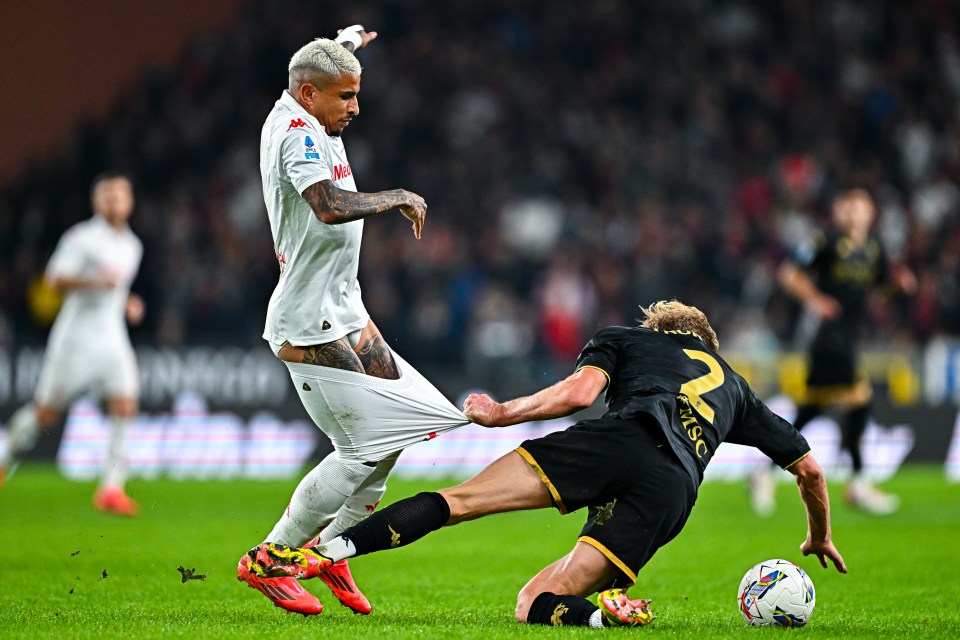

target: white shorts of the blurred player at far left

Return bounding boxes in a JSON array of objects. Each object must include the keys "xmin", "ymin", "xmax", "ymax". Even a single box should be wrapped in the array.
[{"xmin": 34, "ymin": 341, "xmax": 140, "ymax": 409}]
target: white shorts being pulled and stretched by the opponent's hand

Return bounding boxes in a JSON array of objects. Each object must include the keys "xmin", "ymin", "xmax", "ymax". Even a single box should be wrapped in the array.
[{"xmin": 284, "ymin": 353, "xmax": 470, "ymax": 462}]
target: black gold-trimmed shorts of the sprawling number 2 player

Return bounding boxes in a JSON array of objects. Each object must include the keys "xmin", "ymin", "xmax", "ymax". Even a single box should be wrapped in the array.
[{"xmin": 517, "ymin": 419, "xmax": 697, "ymax": 586}]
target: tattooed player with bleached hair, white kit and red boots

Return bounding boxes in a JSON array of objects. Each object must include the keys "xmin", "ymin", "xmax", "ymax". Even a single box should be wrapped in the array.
[{"xmin": 237, "ymin": 25, "xmax": 468, "ymax": 615}]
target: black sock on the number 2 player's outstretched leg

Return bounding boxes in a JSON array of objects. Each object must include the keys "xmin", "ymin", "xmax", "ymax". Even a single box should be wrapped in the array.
[{"xmin": 343, "ymin": 492, "xmax": 450, "ymax": 556}]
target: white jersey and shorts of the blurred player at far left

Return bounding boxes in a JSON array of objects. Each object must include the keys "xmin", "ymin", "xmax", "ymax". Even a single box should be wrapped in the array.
[{"xmin": 36, "ymin": 215, "xmax": 143, "ymax": 408}]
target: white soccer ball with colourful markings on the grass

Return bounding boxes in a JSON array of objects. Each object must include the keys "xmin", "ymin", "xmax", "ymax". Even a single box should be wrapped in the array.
[{"xmin": 737, "ymin": 560, "xmax": 817, "ymax": 627}]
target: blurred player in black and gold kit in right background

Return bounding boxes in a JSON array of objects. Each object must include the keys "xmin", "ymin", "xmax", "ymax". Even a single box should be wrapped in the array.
[{"xmin": 751, "ymin": 189, "xmax": 917, "ymax": 515}]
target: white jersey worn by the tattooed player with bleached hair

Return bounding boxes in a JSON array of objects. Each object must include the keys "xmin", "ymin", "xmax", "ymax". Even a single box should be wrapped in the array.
[{"xmin": 260, "ymin": 91, "xmax": 370, "ymax": 346}]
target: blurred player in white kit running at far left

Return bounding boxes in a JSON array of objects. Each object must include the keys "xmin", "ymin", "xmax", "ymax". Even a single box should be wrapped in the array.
[{"xmin": 0, "ymin": 173, "xmax": 144, "ymax": 516}]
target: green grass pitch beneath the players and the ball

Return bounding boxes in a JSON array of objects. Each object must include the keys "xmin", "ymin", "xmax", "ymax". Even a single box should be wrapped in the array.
[{"xmin": 0, "ymin": 465, "xmax": 960, "ymax": 640}]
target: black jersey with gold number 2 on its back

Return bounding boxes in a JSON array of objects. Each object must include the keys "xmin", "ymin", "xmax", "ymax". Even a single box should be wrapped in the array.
[{"xmin": 577, "ymin": 327, "xmax": 810, "ymax": 484}]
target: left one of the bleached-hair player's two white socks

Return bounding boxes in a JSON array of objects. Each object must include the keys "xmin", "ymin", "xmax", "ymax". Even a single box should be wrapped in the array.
[{"xmin": 264, "ymin": 451, "xmax": 375, "ymax": 547}]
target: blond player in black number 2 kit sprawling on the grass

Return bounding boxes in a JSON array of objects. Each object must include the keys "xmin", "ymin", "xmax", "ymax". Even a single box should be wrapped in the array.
[{"xmin": 242, "ymin": 301, "xmax": 847, "ymax": 627}]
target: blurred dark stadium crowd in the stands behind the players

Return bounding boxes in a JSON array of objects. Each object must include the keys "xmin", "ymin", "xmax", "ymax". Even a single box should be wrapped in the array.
[{"xmin": 0, "ymin": 0, "xmax": 960, "ymax": 393}]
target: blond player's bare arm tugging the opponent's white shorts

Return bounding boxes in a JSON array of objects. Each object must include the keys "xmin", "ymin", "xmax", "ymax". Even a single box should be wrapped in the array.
[{"xmin": 463, "ymin": 367, "xmax": 607, "ymax": 427}]
